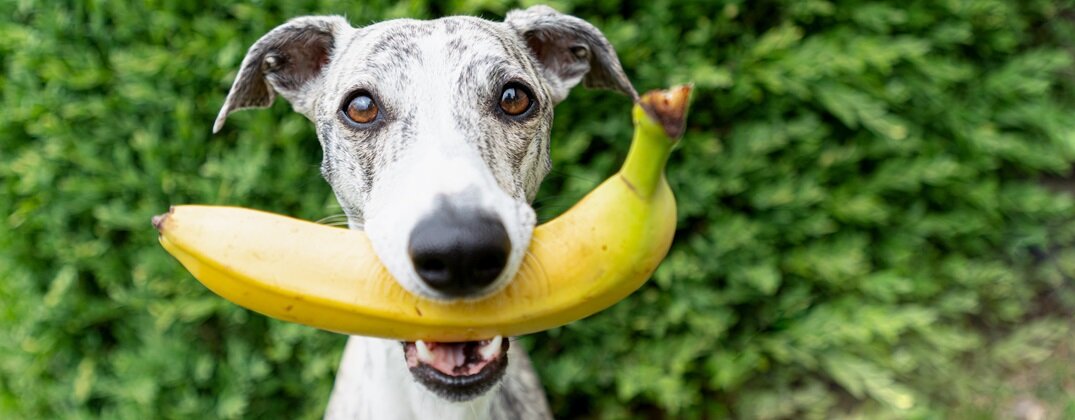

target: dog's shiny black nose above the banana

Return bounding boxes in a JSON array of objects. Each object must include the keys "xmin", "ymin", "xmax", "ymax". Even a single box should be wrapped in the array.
[{"xmin": 407, "ymin": 206, "xmax": 512, "ymax": 298}]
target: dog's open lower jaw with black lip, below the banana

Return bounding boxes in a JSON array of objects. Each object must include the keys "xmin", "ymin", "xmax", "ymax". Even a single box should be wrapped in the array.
[{"xmin": 402, "ymin": 338, "xmax": 511, "ymax": 402}]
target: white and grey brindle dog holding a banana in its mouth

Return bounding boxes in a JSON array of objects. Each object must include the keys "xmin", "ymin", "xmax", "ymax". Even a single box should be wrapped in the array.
[{"xmin": 213, "ymin": 5, "xmax": 637, "ymax": 419}]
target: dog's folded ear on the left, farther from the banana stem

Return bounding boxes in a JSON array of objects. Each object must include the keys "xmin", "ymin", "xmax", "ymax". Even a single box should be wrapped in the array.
[{"xmin": 213, "ymin": 16, "xmax": 350, "ymax": 133}]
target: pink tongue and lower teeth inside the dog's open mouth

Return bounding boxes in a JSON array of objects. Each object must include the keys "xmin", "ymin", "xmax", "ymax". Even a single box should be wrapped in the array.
[{"xmin": 406, "ymin": 336, "xmax": 503, "ymax": 376}]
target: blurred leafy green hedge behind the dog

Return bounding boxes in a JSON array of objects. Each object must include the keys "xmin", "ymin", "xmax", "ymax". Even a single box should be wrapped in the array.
[{"xmin": 6, "ymin": 0, "xmax": 1075, "ymax": 418}]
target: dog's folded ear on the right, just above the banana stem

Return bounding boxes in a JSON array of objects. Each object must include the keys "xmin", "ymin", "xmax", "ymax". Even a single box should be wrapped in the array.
[{"xmin": 504, "ymin": 5, "xmax": 639, "ymax": 102}]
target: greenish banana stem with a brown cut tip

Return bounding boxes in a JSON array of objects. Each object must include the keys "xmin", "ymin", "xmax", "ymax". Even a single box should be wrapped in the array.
[{"xmin": 619, "ymin": 85, "xmax": 691, "ymax": 199}]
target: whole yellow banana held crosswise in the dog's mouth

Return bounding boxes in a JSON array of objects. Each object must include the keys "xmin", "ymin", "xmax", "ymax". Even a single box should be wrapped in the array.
[{"xmin": 153, "ymin": 86, "xmax": 691, "ymax": 342}]
